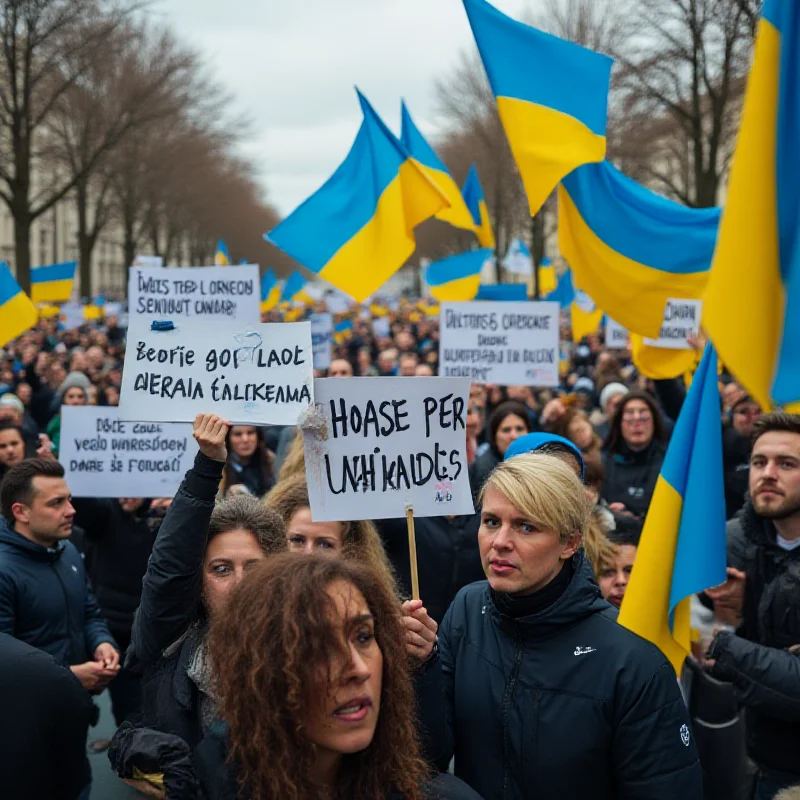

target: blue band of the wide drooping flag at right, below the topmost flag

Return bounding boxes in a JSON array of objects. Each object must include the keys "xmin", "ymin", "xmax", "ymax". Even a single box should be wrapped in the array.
[{"xmin": 563, "ymin": 161, "xmax": 721, "ymax": 275}]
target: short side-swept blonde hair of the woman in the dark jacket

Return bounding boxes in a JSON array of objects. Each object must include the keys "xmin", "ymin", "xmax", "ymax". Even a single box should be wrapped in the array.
[{"xmin": 480, "ymin": 453, "xmax": 590, "ymax": 543}]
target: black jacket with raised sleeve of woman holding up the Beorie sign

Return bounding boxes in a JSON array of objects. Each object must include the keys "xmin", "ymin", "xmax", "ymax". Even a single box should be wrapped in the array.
[{"xmin": 130, "ymin": 453, "xmax": 224, "ymax": 747}]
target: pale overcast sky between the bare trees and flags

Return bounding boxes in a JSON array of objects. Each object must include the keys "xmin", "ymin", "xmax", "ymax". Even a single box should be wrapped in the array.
[{"xmin": 152, "ymin": 0, "xmax": 535, "ymax": 215}]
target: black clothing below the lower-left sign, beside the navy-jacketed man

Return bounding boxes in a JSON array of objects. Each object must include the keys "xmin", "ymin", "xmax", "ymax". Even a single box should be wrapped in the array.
[{"xmin": 72, "ymin": 498, "xmax": 162, "ymax": 638}]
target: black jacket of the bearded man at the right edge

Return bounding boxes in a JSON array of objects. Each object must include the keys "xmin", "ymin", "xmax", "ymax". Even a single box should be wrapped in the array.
[{"xmin": 719, "ymin": 500, "xmax": 800, "ymax": 775}]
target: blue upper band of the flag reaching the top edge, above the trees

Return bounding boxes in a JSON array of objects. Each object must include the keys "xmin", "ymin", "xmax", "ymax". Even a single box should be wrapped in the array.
[{"xmin": 464, "ymin": 0, "xmax": 614, "ymax": 136}]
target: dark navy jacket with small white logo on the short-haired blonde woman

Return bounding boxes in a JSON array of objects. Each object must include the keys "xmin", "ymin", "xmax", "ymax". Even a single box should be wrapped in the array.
[{"xmin": 420, "ymin": 555, "xmax": 702, "ymax": 800}]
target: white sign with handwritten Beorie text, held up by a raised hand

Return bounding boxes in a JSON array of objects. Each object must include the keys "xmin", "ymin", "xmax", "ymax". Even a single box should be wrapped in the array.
[{"xmin": 119, "ymin": 317, "xmax": 314, "ymax": 425}]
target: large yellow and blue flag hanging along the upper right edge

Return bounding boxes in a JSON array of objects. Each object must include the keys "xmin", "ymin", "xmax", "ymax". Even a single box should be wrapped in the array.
[{"xmin": 703, "ymin": 0, "xmax": 800, "ymax": 410}]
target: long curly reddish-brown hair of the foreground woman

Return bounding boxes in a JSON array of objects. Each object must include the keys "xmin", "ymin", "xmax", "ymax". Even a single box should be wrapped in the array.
[{"xmin": 209, "ymin": 553, "xmax": 427, "ymax": 800}]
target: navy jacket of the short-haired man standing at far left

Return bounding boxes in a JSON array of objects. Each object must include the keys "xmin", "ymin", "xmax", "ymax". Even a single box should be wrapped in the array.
[{"xmin": 0, "ymin": 520, "xmax": 116, "ymax": 666}]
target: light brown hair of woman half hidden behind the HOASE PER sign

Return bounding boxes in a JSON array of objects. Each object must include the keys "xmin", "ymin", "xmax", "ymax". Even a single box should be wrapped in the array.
[{"xmin": 263, "ymin": 474, "xmax": 398, "ymax": 595}]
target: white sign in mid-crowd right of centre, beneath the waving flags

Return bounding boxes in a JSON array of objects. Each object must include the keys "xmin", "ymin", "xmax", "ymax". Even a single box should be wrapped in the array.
[{"xmin": 439, "ymin": 302, "xmax": 559, "ymax": 386}]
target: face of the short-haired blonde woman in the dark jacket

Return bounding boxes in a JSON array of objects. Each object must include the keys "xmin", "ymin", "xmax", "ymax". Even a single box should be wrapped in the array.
[{"xmin": 478, "ymin": 486, "xmax": 580, "ymax": 595}]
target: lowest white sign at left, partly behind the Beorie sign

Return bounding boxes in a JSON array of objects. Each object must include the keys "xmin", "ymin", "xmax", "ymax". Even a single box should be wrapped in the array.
[{"xmin": 58, "ymin": 406, "xmax": 197, "ymax": 497}]
